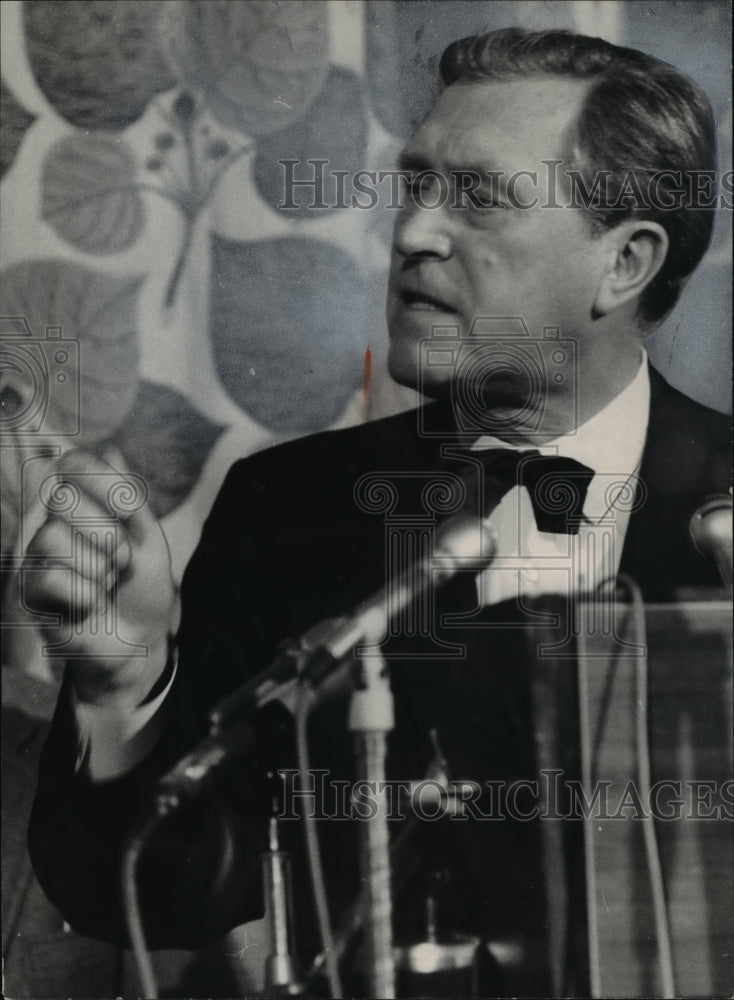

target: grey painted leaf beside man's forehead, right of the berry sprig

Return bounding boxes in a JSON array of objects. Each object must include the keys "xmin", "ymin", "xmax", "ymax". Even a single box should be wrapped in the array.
[{"xmin": 254, "ymin": 67, "xmax": 367, "ymax": 219}]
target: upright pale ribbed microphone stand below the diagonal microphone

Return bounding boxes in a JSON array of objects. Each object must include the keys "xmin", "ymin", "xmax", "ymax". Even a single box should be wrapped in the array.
[{"xmin": 347, "ymin": 646, "xmax": 395, "ymax": 1000}]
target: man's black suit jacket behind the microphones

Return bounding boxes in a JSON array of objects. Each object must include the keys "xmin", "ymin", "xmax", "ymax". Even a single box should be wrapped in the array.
[{"xmin": 30, "ymin": 372, "xmax": 729, "ymax": 988}]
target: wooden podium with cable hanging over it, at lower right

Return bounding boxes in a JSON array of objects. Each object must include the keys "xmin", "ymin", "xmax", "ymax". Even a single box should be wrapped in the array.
[{"xmin": 528, "ymin": 592, "xmax": 734, "ymax": 996}]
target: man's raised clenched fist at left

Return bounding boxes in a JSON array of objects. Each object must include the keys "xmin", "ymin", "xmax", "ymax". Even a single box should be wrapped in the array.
[{"xmin": 23, "ymin": 451, "xmax": 179, "ymax": 709}]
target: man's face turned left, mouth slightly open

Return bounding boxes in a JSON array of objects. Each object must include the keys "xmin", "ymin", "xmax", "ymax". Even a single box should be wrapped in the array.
[{"xmin": 388, "ymin": 77, "xmax": 605, "ymax": 411}]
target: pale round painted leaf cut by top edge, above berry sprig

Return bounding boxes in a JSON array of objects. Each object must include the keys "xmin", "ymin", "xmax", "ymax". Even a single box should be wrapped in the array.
[{"xmin": 166, "ymin": 0, "xmax": 329, "ymax": 136}]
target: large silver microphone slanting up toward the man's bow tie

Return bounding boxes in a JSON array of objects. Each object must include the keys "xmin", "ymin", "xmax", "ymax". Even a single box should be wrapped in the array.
[{"xmin": 209, "ymin": 514, "xmax": 496, "ymax": 732}]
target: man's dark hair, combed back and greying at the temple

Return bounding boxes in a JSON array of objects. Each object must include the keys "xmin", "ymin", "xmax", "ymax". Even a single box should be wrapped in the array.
[{"xmin": 440, "ymin": 28, "xmax": 716, "ymax": 321}]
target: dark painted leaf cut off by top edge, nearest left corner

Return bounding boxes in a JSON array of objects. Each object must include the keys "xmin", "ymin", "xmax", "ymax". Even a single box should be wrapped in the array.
[{"xmin": 23, "ymin": 0, "xmax": 176, "ymax": 129}]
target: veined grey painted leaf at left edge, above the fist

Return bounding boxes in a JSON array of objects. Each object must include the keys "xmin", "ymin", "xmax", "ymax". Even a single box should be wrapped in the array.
[{"xmin": 0, "ymin": 260, "xmax": 143, "ymax": 445}]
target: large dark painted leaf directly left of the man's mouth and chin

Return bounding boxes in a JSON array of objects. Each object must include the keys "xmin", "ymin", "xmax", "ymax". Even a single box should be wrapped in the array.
[{"xmin": 210, "ymin": 234, "xmax": 368, "ymax": 432}]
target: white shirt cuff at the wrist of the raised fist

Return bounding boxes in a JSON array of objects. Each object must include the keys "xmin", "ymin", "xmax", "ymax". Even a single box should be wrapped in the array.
[{"xmin": 71, "ymin": 648, "xmax": 178, "ymax": 781}]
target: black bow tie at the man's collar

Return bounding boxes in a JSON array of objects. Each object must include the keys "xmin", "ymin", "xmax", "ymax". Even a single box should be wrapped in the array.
[{"xmin": 459, "ymin": 448, "xmax": 594, "ymax": 535}]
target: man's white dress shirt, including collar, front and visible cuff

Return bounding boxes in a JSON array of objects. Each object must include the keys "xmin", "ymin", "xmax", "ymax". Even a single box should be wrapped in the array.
[{"xmin": 75, "ymin": 354, "xmax": 650, "ymax": 781}]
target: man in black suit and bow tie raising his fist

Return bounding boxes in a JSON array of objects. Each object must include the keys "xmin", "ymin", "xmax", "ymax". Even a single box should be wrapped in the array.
[{"xmin": 24, "ymin": 29, "xmax": 728, "ymax": 993}]
